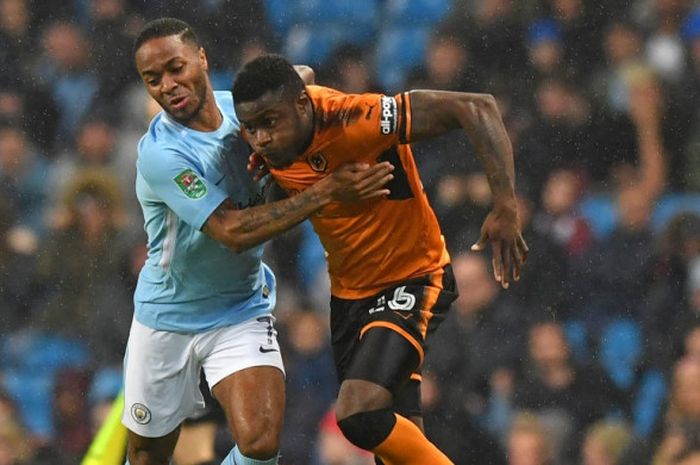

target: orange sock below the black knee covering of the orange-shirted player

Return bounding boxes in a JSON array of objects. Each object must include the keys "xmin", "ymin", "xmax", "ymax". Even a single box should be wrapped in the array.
[{"xmin": 372, "ymin": 414, "xmax": 454, "ymax": 465}]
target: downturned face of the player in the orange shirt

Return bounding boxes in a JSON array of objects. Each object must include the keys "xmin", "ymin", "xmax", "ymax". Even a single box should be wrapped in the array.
[{"xmin": 236, "ymin": 89, "xmax": 313, "ymax": 168}]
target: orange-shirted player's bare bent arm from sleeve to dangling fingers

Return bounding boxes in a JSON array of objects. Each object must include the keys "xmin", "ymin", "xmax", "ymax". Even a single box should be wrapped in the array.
[{"xmin": 410, "ymin": 90, "xmax": 528, "ymax": 288}]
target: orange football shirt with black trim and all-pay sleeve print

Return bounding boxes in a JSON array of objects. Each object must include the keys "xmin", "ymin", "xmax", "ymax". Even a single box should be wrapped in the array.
[{"xmin": 270, "ymin": 86, "xmax": 450, "ymax": 299}]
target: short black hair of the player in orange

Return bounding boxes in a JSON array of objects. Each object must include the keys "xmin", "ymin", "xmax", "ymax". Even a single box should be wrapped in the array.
[{"xmin": 232, "ymin": 53, "xmax": 304, "ymax": 103}]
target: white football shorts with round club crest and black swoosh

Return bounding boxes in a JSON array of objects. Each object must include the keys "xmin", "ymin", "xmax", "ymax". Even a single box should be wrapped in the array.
[{"xmin": 122, "ymin": 316, "xmax": 284, "ymax": 438}]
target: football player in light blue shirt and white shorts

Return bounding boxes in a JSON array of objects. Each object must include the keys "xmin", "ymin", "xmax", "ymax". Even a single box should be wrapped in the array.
[{"xmin": 122, "ymin": 18, "xmax": 393, "ymax": 465}]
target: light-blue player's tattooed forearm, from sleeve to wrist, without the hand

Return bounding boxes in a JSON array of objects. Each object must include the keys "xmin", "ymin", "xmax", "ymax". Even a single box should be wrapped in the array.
[{"xmin": 204, "ymin": 183, "xmax": 331, "ymax": 252}]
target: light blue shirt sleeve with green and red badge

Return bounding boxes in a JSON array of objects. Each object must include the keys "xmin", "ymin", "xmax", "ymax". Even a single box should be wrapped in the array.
[{"xmin": 137, "ymin": 145, "xmax": 228, "ymax": 230}]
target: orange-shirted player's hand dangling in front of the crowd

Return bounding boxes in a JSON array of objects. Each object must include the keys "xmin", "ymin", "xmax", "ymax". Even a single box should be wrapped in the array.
[{"xmin": 471, "ymin": 202, "xmax": 529, "ymax": 289}]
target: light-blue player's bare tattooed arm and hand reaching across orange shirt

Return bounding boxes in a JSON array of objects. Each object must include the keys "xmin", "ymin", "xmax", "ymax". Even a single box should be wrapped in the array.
[{"xmin": 202, "ymin": 162, "xmax": 394, "ymax": 252}]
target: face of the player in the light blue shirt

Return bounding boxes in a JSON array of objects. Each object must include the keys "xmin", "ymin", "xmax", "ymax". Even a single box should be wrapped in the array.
[{"xmin": 136, "ymin": 36, "xmax": 209, "ymax": 124}]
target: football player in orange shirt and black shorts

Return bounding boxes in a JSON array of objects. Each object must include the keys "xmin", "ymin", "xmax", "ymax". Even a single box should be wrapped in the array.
[{"xmin": 233, "ymin": 55, "xmax": 528, "ymax": 465}]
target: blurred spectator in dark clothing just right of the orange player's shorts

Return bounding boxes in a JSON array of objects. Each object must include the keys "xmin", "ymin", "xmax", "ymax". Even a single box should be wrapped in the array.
[{"xmin": 425, "ymin": 253, "xmax": 529, "ymax": 442}]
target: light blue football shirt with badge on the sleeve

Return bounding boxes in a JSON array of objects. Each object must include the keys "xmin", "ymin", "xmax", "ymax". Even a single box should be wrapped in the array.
[{"xmin": 134, "ymin": 91, "xmax": 275, "ymax": 332}]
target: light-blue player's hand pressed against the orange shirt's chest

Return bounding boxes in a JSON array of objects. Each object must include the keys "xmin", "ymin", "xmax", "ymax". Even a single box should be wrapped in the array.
[{"xmin": 323, "ymin": 162, "xmax": 394, "ymax": 202}]
